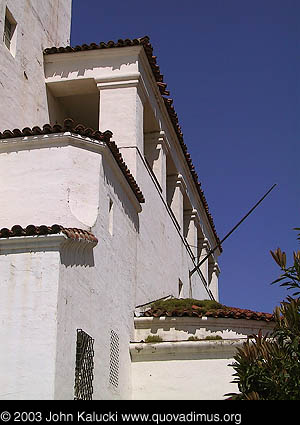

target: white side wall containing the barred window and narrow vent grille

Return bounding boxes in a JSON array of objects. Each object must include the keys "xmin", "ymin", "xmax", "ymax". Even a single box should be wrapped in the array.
[{"xmin": 55, "ymin": 156, "xmax": 138, "ymax": 400}]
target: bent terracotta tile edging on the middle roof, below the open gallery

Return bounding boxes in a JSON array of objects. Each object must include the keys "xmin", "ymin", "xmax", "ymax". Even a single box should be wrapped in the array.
[{"xmin": 0, "ymin": 118, "xmax": 145, "ymax": 203}]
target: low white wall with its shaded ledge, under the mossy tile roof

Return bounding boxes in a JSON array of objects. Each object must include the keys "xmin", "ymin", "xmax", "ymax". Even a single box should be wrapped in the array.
[{"xmin": 130, "ymin": 340, "xmax": 242, "ymax": 400}]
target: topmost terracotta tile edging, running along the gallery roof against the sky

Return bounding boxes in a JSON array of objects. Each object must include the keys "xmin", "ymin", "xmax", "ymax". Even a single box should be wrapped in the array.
[{"xmin": 44, "ymin": 36, "xmax": 222, "ymax": 252}]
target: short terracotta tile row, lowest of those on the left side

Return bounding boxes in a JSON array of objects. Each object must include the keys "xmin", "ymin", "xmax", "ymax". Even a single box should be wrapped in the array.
[{"xmin": 0, "ymin": 224, "xmax": 98, "ymax": 245}]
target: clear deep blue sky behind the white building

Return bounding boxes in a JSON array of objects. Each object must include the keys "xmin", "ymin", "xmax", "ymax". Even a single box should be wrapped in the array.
[{"xmin": 71, "ymin": 0, "xmax": 300, "ymax": 312}]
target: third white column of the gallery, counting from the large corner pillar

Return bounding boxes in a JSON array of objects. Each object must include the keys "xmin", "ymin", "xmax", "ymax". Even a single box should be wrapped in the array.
[{"xmin": 167, "ymin": 174, "xmax": 185, "ymax": 230}]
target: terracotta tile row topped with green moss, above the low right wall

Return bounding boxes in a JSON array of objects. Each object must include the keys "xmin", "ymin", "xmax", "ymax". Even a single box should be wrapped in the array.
[{"xmin": 144, "ymin": 306, "xmax": 274, "ymax": 322}]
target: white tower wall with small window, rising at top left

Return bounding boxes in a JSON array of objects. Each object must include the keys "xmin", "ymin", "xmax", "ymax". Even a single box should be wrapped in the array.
[{"xmin": 0, "ymin": 0, "xmax": 72, "ymax": 131}]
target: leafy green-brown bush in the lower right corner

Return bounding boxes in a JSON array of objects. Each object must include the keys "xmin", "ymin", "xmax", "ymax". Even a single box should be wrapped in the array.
[{"xmin": 227, "ymin": 229, "xmax": 300, "ymax": 400}]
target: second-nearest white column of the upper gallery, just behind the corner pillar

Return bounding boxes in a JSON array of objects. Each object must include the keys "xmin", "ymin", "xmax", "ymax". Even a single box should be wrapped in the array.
[{"xmin": 144, "ymin": 131, "xmax": 167, "ymax": 199}]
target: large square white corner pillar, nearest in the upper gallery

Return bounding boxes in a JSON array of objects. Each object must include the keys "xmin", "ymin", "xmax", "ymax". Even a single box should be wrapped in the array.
[{"xmin": 97, "ymin": 79, "xmax": 145, "ymax": 177}]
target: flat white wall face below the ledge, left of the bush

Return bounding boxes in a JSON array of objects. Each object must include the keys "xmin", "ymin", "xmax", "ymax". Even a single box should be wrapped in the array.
[{"xmin": 132, "ymin": 359, "xmax": 238, "ymax": 400}]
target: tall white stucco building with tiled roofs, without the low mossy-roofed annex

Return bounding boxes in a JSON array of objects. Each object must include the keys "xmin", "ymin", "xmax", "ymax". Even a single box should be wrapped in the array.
[{"xmin": 0, "ymin": 0, "xmax": 274, "ymax": 399}]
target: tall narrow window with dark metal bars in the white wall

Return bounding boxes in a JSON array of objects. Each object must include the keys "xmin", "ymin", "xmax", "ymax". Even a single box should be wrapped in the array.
[{"xmin": 74, "ymin": 329, "xmax": 94, "ymax": 400}]
